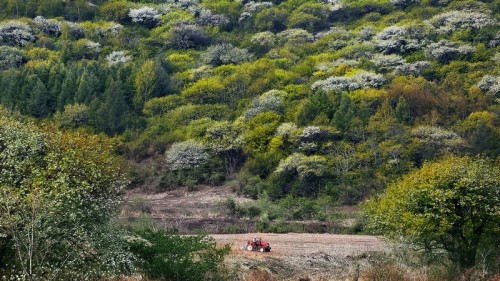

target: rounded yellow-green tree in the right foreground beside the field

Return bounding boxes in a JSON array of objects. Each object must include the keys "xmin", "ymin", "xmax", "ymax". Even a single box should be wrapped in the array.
[{"xmin": 366, "ymin": 156, "xmax": 500, "ymax": 268}]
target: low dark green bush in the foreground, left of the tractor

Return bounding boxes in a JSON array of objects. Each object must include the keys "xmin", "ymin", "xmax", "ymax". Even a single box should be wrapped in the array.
[{"xmin": 129, "ymin": 230, "xmax": 230, "ymax": 281}]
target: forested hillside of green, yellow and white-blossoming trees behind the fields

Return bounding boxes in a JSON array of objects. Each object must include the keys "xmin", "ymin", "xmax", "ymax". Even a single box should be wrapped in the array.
[{"xmin": 0, "ymin": 0, "xmax": 500, "ymax": 213}]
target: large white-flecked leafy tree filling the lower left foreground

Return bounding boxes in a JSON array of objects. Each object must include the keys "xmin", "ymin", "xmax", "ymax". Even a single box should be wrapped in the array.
[{"xmin": 0, "ymin": 117, "xmax": 130, "ymax": 280}]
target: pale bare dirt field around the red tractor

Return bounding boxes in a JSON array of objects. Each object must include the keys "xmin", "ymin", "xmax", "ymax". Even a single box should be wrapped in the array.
[{"xmin": 211, "ymin": 233, "xmax": 388, "ymax": 281}]
